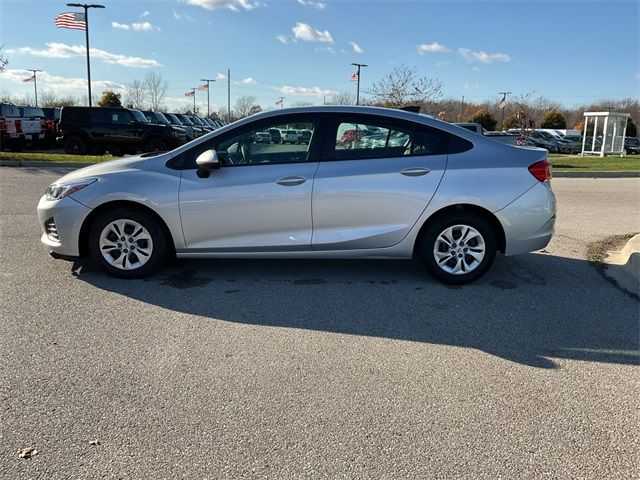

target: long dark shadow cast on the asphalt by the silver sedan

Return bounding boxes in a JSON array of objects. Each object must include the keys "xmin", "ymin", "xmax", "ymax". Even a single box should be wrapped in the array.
[{"xmin": 73, "ymin": 253, "xmax": 640, "ymax": 368}]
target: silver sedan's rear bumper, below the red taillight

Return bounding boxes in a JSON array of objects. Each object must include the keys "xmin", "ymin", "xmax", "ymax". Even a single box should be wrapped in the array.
[{"xmin": 496, "ymin": 182, "xmax": 556, "ymax": 255}]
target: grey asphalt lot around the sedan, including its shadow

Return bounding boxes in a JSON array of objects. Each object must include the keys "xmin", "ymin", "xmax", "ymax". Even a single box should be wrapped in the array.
[{"xmin": 0, "ymin": 168, "xmax": 640, "ymax": 480}]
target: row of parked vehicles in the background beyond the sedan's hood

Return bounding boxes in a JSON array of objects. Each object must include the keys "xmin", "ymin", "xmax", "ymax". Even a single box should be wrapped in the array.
[{"xmin": 0, "ymin": 103, "xmax": 224, "ymax": 156}]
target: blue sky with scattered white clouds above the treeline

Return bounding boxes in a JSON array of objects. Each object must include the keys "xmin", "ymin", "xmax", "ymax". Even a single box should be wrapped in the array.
[{"xmin": 0, "ymin": 0, "xmax": 640, "ymax": 110}]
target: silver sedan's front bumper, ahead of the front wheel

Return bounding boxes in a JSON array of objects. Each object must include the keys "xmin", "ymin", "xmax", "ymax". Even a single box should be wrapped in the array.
[{"xmin": 38, "ymin": 195, "xmax": 91, "ymax": 257}]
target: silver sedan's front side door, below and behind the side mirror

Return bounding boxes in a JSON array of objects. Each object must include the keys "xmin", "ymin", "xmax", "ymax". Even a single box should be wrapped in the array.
[{"xmin": 180, "ymin": 116, "xmax": 318, "ymax": 253}]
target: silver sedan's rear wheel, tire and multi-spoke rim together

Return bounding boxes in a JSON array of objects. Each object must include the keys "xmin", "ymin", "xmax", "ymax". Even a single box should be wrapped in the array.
[{"xmin": 420, "ymin": 213, "xmax": 497, "ymax": 285}]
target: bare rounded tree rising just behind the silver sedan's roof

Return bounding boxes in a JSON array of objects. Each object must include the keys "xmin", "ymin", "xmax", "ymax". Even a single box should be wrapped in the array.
[{"xmin": 367, "ymin": 65, "xmax": 443, "ymax": 107}]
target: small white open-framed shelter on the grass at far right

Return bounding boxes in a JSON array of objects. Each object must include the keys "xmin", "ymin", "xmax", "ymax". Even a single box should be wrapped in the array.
[{"xmin": 581, "ymin": 112, "xmax": 630, "ymax": 157}]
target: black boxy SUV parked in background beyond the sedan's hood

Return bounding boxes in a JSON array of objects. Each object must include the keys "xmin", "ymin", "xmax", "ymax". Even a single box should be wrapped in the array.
[{"xmin": 57, "ymin": 107, "xmax": 186, "ymax": 156}]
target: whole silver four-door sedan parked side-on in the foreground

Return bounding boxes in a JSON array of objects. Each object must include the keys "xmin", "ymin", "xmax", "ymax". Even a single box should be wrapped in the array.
[{"xmin": 38, "ymin": 106, "xmax": 556, "ymax": 284}]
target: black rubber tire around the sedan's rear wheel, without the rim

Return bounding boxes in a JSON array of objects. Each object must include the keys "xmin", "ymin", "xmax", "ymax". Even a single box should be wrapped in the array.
[{"xmin": 419, "ymin": 212, "xmax": 497, "ymax": 285}]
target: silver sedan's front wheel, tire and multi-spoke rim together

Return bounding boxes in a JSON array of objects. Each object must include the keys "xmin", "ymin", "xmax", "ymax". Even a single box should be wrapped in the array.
[{"xmin": 89, "ymin": 208, "xmax": 168, "ymax": 278}]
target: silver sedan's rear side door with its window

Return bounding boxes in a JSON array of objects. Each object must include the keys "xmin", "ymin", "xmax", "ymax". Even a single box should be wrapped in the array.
[{"xmin": 312, "ymin": 114, "xmax": 448, "ymax": 250}]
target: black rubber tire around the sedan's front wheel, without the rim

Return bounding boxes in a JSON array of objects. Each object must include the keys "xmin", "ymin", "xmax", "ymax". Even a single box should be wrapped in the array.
[{"xmin": 89, "ymin": 208, "xmax": 170, "ymax": 278}]
